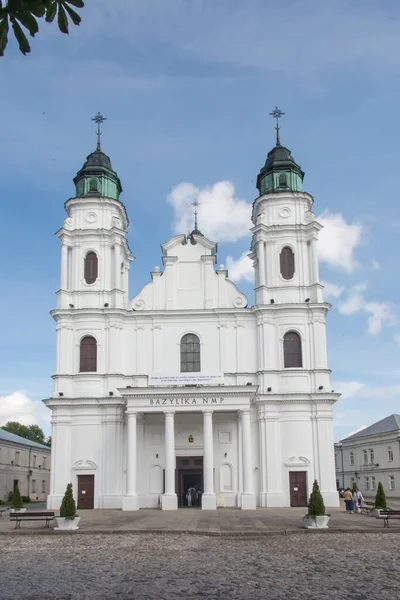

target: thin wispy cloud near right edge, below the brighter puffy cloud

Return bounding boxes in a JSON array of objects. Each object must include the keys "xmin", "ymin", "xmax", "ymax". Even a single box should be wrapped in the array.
[{"xmin": 338, "ymin": 283, "xmax": 397, "ymax": 335}]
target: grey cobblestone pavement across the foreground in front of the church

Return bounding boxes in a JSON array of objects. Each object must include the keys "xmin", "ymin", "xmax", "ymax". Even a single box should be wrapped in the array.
[{"xmin": 0, "ymin": 533, "xmax": 400, "ymax": 600}]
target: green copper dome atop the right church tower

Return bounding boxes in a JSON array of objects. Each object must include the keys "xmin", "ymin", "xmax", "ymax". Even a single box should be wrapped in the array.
[{"xmin": 257, "ymin": 138, "xmax": 304, "ymax": 196}]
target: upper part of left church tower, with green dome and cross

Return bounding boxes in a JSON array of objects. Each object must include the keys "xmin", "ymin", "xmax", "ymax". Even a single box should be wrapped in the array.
[{"xmin": 57, "ymin": 114, "xmax": 133, "ymax": 310}]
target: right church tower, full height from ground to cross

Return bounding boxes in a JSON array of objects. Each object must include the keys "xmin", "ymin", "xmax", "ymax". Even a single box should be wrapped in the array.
[{"xmin": 250, "ymin": 107, "xmax": 338, "ymax": 506}]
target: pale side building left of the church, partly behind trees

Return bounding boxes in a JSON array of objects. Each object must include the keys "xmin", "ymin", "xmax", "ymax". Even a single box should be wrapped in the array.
[{"xmin": 0, "ymin": 428, "xmax": 51, "ymax": 500}]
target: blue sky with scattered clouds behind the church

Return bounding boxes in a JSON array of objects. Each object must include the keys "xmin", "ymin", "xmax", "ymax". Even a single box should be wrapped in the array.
[{"xmin": 0, "ymin": 0, "xmax": 400, "ymax": 439}]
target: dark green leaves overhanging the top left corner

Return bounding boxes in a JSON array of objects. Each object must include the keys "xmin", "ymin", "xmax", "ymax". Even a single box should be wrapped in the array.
[{"xmin": 0, "ymin": 0, "xmax": 85, "ymax": 56}]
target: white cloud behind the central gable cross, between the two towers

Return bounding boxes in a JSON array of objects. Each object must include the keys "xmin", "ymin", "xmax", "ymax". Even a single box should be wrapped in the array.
[{"xmin": 168, "ymin": 181, "xmax": 251, "ymax": 242}]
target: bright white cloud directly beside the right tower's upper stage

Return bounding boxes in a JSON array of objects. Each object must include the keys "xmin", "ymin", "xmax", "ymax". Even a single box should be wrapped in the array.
[{"xmin": 317, "ymin": 211, "xmax": 363, "ymax": 273}]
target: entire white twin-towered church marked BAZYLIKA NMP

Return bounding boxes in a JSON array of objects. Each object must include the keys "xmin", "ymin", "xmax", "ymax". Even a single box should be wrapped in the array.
[{"xmin": 45, "ymin": 116, "xmax": 338, "ymax": 510}]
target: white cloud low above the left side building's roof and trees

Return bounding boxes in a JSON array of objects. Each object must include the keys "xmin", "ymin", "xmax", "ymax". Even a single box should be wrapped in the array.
[{"xmin": 0, "ymin": 391, "xmax": 51, "ymax": 431}]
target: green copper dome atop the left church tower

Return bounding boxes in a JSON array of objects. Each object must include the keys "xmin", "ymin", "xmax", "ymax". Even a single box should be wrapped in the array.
[{"xmin": 74, "ymin": 149, "xmax": 122, "ymax": 200}]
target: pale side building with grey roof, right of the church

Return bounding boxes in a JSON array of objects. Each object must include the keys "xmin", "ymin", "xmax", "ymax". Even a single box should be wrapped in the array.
[{"xmin": 335, "ymin": 414, "xmax": 400, "ymax": 498}]
